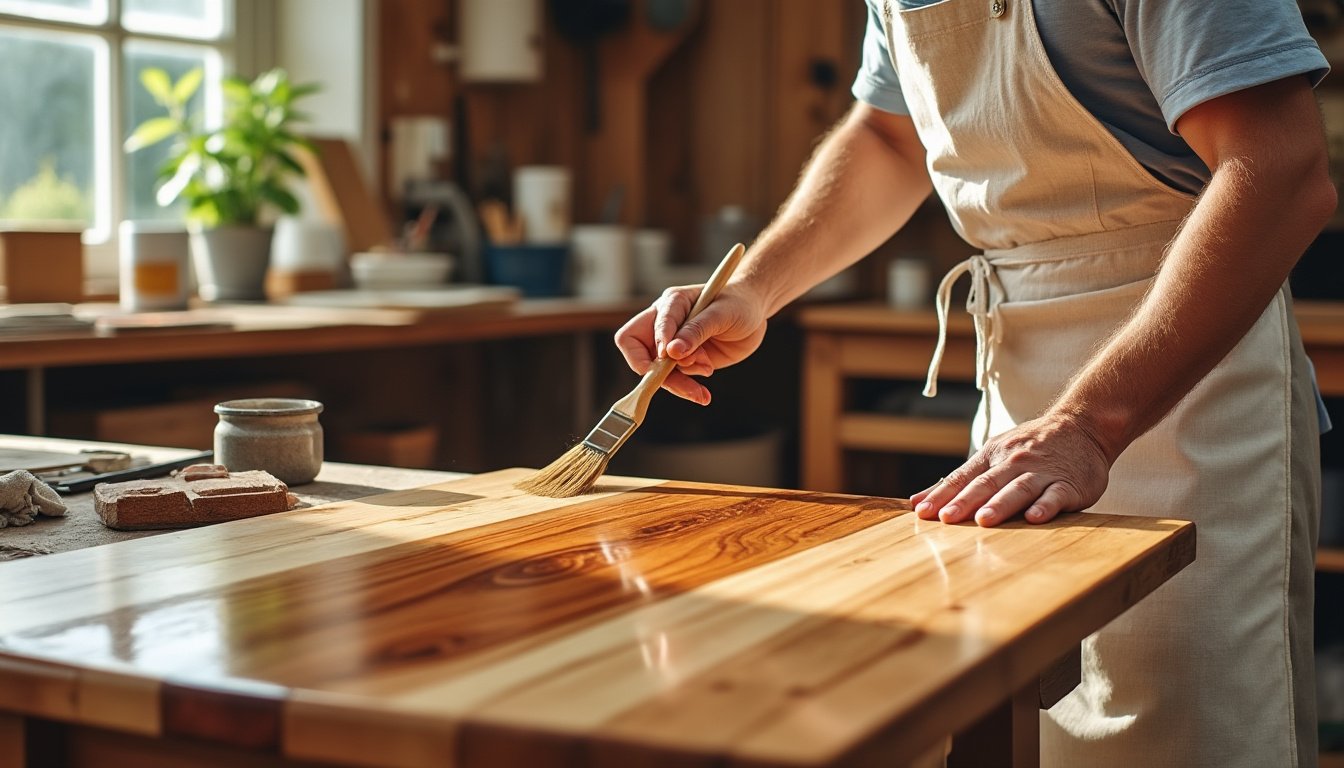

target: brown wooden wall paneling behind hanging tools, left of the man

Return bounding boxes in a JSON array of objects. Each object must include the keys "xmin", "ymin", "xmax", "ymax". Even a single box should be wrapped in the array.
[{"xmin": 379, "ymin": 0, "xmax": 863, "ymax": 267}]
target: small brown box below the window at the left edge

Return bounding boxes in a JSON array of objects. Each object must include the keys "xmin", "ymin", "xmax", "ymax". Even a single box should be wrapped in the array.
[{"xmin": 0, "ymin": 230, "xmax": 83, "ymax": 304}]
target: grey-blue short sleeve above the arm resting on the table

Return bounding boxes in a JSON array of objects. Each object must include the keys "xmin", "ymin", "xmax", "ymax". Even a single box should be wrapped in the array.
[{"xmin": 1111, "ymin": 0, "xmax": 1329, "ymax": 132}]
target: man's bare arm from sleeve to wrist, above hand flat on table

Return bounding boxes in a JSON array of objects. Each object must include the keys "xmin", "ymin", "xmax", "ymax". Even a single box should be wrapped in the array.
[{"xmin": 1051, "ymin": 83, "xmax": 1335, "ymax": 461}]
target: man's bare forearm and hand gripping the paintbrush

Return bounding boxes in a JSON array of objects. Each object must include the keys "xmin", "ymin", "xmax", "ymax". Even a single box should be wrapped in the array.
[{"xmin": 616, "ymin": 102, "xmax": 931, "ymax": 405}]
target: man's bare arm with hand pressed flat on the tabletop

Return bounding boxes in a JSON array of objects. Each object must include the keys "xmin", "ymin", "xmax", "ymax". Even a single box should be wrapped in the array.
[{"xmin": 913, "ymin": 77, "xmax": 1336, "ymax": 526}]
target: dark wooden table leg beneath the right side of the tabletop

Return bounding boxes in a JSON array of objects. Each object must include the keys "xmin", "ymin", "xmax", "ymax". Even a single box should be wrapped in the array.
[{"xmin": 948, "ymin": 681, "xmax": 1040, "ymax": 768}]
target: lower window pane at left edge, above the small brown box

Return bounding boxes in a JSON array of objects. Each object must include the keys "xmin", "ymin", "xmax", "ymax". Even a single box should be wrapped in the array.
[{"xmin": 0, "ymin": 28, "xmax": 97, "ymax": 226}]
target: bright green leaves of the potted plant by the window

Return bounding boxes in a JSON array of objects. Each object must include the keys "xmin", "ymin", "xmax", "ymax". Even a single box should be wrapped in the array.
[{"xmin": 125, "ymin": 69, "xmax": 319, "ymax": 227}]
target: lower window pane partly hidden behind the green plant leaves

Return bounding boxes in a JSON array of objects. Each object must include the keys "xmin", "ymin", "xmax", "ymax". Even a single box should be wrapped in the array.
[{"xmin": 122, "ymin": 42, "xmax": 220, "ymax": 221}]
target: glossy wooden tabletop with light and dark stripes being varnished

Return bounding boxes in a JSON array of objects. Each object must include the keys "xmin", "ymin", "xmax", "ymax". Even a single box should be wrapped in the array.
[{"xmin": 0, "ymin": 471, "xmax": 1193, "ymax": 765}]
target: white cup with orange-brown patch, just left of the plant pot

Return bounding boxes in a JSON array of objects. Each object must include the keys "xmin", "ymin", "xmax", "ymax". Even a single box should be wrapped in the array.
[{"xmin": 117, "ymin": 221, "xmax": 191, "ymax": 312}]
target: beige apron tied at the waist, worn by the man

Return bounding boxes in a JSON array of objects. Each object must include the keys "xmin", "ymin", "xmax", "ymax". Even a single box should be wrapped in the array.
[{"xmin": 883, "ymin": 0, "xmax": 1320, "ymax": 768}]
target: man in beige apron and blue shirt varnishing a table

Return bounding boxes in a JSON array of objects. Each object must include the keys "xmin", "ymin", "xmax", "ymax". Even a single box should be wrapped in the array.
[{"xmin": 617, "ymin": 0, "xmax": 1336, "ymax": 768}]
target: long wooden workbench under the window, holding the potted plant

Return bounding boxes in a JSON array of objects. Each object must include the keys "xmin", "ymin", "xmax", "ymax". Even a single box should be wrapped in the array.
[{"xmin": 0, "ymin": 300, "xmax": 642, "ymax": 462}]
